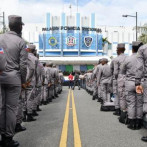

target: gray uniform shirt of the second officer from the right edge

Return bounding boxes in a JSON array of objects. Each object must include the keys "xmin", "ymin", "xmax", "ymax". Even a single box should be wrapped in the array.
[{"xmin": 121, "ymin": 53, "xmax": 137, "ymax": 81}]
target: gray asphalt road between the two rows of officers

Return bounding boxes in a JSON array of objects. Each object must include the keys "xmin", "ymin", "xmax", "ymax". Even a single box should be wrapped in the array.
[{"xmin": 15, "ymin": 87, "xmax": 147, "ymax": 147}]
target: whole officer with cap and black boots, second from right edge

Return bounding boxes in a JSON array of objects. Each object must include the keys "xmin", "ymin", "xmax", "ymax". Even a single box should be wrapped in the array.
[{"xmin": 122, "ymin": 42, "xmax": 143, "ymax": 130}]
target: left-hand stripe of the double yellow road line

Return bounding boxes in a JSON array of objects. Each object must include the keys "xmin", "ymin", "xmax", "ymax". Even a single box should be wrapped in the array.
[{"xmin": 59, "ymin": 90, "xmax": 70, "ymax": 147}]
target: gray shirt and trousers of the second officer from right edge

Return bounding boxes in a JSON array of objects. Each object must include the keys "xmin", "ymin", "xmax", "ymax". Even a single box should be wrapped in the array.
[{"xmin": 122, "ymin": 53, "xmax": 143, "ymax": 119}]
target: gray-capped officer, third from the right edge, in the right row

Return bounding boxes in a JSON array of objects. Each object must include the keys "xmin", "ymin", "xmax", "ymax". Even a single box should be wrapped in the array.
[{"xmin": 114, "ymin": 43, "xmax": 127, "ymax": 123}]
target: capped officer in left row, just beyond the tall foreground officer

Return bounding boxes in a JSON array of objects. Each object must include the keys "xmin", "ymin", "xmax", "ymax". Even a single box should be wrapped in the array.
[{"xmin": 24, "ymin": 44, "xmax": 38, "ymax": 122}]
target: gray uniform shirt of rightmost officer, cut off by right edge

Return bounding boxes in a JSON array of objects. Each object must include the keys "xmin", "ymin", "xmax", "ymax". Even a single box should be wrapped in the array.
[{"xmin": 135, "ymin": 44, "xmax": 147, "ymax": 85}]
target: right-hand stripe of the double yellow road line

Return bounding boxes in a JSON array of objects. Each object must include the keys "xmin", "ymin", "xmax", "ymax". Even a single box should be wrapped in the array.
[{"xmin": 72, "ymin": 91, "xmax": 82, "ymax": 147}]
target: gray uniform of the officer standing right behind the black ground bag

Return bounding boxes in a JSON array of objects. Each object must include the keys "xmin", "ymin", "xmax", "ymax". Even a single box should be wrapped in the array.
[{"xmin": 97, "ymin": 64, "xmax": 112, "ymax": 103}]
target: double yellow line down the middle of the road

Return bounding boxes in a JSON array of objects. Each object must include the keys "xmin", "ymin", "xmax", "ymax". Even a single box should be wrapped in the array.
[{"xmin": 59, "ymin": 90, "xmax": 82, "ymax": 147}]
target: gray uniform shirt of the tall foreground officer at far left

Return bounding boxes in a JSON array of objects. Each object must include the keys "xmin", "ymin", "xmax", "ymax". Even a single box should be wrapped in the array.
[{"xmin": 0, "ymin": 31, "xmax": 28, "ymax": 85}]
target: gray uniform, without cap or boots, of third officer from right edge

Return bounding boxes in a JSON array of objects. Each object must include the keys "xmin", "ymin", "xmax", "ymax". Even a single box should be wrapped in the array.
[{"xmin": 114, "ymin": 54, "xmax": 126, "ymax": 110}]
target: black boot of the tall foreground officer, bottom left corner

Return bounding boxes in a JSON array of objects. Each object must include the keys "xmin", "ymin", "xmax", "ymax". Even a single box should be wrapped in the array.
[{"xmin": 4, "ymin": 137, "xmax": 19, "ymax": 147}]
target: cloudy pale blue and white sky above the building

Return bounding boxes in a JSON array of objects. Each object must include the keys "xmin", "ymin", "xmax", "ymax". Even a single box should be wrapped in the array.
[{"xmin": 0, "ymin": 0, "xmax": 147, "ymax": 26}]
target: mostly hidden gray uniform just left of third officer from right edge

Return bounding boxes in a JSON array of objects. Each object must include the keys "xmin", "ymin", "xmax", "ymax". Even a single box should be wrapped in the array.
[{"xmin": 110, "ymin": 57, "xmax": 120, "ymax": 109}]
